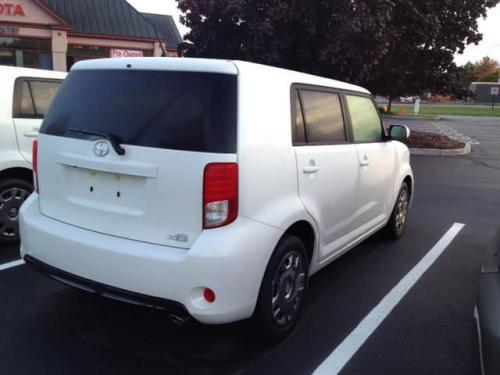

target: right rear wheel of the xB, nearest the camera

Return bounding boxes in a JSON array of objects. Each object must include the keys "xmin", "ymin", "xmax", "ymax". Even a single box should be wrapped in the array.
[{"xmin": 247, "ymin": 236, "xmax": 309, "ymax": 342}]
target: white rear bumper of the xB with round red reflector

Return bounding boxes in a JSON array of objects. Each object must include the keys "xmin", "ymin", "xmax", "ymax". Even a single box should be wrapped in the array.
[{"xmin": 20, "ymin": 194, "xmax": 282, "ymax": 324}]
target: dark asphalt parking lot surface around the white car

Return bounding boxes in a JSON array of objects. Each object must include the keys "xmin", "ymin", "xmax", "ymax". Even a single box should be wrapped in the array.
[{"xmin": 0, "ymin": 117, "xmax": 500, "ymax": 375}]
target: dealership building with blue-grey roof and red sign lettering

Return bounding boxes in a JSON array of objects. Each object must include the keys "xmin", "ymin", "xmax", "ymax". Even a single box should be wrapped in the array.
[{"xmin": 0, "ymin": 0, "xmax": 182, "ymax": 71}]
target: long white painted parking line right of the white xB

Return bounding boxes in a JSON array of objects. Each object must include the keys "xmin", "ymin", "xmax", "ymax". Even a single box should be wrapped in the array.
[{"xmin": 314, "ymin": 223, "xmax": 465, "ymax": 375}]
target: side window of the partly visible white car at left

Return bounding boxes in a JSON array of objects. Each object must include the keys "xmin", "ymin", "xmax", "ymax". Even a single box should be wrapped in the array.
[{"xmin": 14, "ymin": 78, "xmax": 62, "ymax": 119}]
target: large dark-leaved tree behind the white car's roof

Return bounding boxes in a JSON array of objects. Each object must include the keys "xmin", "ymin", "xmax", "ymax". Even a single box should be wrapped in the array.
[{"xmin": 177, "ymin": 0, "xmax": 499, "ymax": 110}]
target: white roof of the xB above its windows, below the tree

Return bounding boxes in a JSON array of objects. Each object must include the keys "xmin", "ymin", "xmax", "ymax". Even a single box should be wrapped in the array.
[{"xmin": 71, "ymin": 57, "xmax": 369, "ymax": 94}]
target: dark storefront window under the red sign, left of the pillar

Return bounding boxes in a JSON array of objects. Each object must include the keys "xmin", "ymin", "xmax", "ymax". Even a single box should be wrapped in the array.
[{"xmin": 0, "ymin": 37, "xmax": 52, "ymax": 70}]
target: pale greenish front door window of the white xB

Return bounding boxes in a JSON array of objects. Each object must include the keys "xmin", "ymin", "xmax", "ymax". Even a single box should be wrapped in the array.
[{"xmin": 346, "ymin": 95, "xmax": 383, "ymax": 142}]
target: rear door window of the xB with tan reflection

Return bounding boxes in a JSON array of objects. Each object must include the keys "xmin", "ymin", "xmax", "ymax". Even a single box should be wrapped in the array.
[{"xmin": 300, "ymin": 90, "xmax": 346, "ymax": 143}]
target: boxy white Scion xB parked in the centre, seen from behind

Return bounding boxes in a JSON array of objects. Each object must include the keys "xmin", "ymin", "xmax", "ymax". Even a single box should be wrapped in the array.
[{"xmin": 21, "ymin": 58, "xmax": 413, "ymax": 339}]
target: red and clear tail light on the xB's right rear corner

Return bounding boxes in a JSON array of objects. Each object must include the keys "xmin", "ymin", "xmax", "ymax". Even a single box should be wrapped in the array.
[{"xmin": 203, "ymin": 163, "xmax": 238, "ymax": 229}]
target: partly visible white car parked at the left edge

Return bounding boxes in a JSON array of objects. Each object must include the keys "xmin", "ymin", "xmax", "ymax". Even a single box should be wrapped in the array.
[{"xmin": 0, "ymin": 66, "xmax": 66, "ymax": 246}]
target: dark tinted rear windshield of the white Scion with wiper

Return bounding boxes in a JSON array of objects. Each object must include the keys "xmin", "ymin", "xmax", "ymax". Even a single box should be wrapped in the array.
[{"xmin": 41, "ymin": 70, "xmax": 237, "ymax": 153}]
